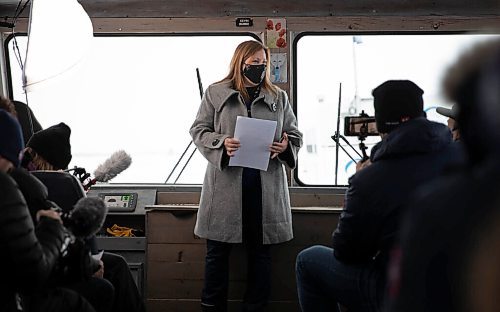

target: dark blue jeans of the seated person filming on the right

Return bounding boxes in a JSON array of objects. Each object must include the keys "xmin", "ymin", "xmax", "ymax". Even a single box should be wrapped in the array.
[{"xmin": 295, "ymin": 246, "xmax": 383, "ymax": 312}]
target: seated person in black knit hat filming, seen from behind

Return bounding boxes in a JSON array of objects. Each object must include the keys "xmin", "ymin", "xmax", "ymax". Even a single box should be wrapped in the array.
[{"xmin": 296, "ymin": 80, "xmax": 462, "ymax": 312}]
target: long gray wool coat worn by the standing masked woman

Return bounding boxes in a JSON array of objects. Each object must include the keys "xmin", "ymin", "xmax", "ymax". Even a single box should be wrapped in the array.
[{"xmin": 189, "ymin": 82, "xmax": 302, "ymax": 244}]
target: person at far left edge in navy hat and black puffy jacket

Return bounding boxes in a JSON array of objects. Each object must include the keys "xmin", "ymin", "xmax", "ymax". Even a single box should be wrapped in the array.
[{"xmin": 0, "ymin": 109, "xmax": 94, "ymax": 312}]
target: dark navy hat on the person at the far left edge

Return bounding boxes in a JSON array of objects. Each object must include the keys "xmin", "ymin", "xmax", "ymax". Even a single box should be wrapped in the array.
[{"xmin": 0, "ymin": 109, "xmax": 24, "ymax": 167}]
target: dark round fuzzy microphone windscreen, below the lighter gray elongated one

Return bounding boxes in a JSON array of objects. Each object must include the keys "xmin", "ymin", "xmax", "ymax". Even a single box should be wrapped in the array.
[{"xmin": 67, "ymin": 197, "xmax": 108, "ymax": 238}]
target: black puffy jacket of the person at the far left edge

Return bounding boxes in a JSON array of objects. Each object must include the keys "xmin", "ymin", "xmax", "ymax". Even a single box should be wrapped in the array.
[{"xmin": 0, "ymin": 172, "xmax": 64, "ymax": 311}]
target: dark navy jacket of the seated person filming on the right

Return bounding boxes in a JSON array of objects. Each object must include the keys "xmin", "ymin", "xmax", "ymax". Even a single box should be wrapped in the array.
[{"xmin": 333, "ymin": 117, "xmax": 461, "ymax": 268}]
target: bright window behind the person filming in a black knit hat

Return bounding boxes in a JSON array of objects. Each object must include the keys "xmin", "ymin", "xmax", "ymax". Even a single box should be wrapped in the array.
[{"xmin": 295, "ymin": 34, "xmax": 493, "ymax": 185}]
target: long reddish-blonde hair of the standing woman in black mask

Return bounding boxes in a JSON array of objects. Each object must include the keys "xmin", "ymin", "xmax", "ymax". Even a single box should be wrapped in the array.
[{"xmin": 219, "ymin": 40, "xmax": 278, "ymax": 101}]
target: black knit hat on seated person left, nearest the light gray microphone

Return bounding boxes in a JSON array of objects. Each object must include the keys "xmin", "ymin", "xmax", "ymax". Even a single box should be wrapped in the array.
[{"xmin": 26, "ymin": 122, "xmax": 72, "ymax": 169}]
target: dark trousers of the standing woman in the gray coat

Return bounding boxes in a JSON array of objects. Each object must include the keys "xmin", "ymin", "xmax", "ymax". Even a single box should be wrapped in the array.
[{"xmin": 201, "ymin": 168, "xmax": 271, "ymax": 311}]
